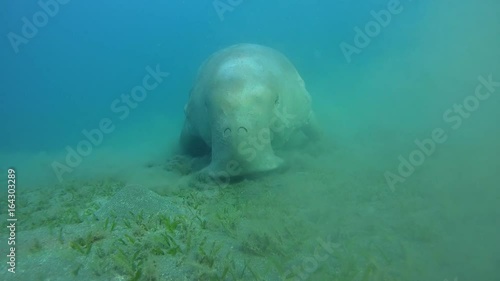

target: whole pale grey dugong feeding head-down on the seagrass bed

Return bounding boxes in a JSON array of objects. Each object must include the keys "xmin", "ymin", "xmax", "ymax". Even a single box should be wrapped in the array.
[{"xmin": 180, "ymin": 44, "xmax": 321, "ymax": 178}]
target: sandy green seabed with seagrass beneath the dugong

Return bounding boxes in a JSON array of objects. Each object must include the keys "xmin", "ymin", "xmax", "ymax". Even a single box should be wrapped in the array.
[{"xmin": 0, "ymin": 109, "xmax": 500, "ymax": 280}]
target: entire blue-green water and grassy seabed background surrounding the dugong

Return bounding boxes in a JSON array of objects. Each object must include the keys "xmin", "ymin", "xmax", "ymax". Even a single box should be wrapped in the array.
[{"xmin": 0, "ymin": 0, "xmax": 500, "ymax": 281}]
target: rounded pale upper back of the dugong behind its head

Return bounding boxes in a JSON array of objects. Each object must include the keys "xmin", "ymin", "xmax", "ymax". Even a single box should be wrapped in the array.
[{"xmin": 186, "ymin": 44, "xmax": 311, "ymax": 138}]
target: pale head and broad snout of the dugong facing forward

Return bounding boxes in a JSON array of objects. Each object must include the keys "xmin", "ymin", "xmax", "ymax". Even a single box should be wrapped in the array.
[{"xmin": 204, "ymin": 72, "xmax": 284, "ymax": 177}]
